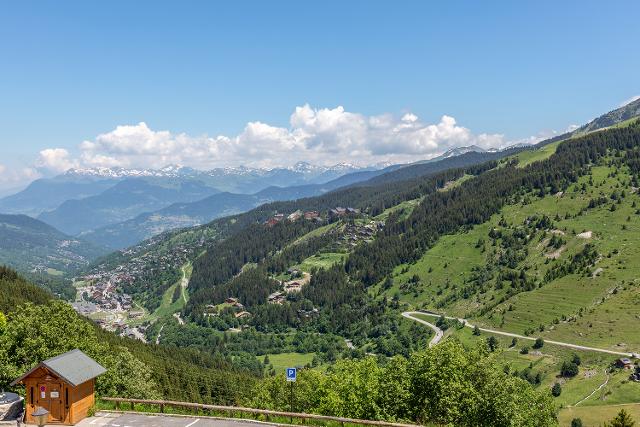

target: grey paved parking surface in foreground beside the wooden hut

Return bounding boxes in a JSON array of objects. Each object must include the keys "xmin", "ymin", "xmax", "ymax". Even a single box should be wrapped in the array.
[{"xmin": 76, "ymin": 412, "xmax": 271, "ymax": 427}]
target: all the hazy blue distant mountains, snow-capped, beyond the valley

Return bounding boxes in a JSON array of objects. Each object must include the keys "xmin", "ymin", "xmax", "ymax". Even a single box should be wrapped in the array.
[{"xmin": 0, "ymin": 100, "xmax": 640, "ymax": 260}]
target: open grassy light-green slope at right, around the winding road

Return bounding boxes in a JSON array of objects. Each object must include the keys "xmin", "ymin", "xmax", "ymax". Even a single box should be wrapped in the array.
[{"xmin": 375, "ymin": 149, "xmax": 640, "ymax": 416}]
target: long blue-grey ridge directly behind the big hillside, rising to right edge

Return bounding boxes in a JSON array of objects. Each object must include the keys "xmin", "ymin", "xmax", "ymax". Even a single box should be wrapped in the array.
[{"xmin": 84, "ymin": 100, "xmax": 640, "ymax": 248}]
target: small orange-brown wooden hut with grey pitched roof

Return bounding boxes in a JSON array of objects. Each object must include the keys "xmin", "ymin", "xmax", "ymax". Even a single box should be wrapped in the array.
[{"xmin": 11, "ymin": 349, "xmax": 106, "ymax": 425}]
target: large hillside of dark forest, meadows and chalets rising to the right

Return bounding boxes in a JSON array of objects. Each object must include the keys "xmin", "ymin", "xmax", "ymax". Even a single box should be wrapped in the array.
[{"xmin": 33, "ymin": 118, "xmax": 640, "ymax": 425}]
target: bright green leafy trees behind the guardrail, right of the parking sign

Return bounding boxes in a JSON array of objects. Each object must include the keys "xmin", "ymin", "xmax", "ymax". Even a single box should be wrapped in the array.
[{"xmin": 252, "ymin": 340, "xmax": 556, "ymax": 426}]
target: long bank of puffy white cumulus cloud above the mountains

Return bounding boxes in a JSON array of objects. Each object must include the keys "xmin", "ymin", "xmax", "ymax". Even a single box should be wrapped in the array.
[{"xmin": 66, "ymin": 104, "xmax": 505, "ymax": 171}]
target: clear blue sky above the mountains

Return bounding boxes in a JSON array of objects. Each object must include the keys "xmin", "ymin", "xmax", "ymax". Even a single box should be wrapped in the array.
[{"xmin": 0, "ymin": 1, "xmax": 640, "ymax": 191}]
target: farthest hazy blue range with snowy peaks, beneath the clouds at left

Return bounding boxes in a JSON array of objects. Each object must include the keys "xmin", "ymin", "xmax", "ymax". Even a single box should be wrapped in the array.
[{"xmin": 0, "ymin": 162, "xmax": 378, "ymax": 224}]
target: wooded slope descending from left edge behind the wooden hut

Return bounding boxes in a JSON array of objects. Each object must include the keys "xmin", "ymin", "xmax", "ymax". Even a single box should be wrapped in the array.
[{"xmin": 0, "ymin": 267, "xmax": 256, "ymax": 404}]
